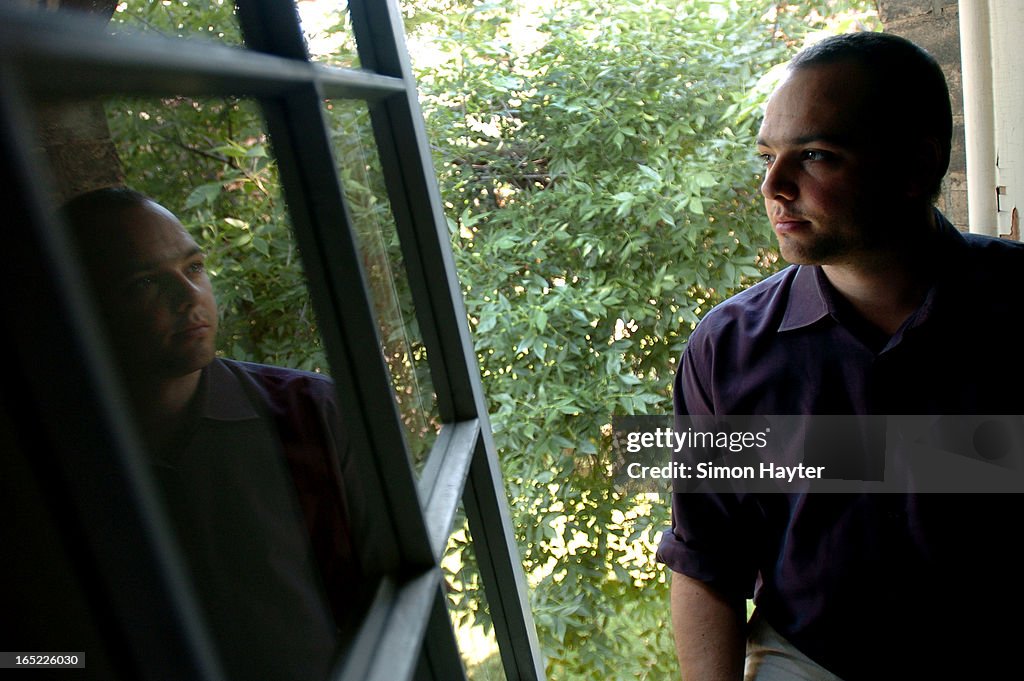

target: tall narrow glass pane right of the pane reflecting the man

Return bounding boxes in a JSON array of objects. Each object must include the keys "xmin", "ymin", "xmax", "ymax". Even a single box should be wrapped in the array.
[{"xmin": 326, "ymin": 100, "xmax": 440, "ymax": 469}]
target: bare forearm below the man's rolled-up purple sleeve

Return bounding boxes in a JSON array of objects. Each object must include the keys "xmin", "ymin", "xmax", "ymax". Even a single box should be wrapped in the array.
[{"xmin": 672, "ymin": 571, "xmax": 746, "ymax": 681}]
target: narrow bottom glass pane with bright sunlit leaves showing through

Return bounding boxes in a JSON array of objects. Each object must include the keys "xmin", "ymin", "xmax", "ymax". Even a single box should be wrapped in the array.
[{"xmin": 441, "ymin": 506, "xmax": 507, "ymax": 681}]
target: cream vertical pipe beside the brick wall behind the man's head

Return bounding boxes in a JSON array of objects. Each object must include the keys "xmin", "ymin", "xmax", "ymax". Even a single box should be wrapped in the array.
[{"xmin": 959, "ymin": 0, "xmax": 998, "ymax": 237}]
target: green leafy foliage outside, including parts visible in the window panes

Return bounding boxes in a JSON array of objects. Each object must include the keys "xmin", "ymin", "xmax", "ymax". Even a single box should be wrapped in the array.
[{"xmin": 108, "ymin": 0, "xmax": 869, "ymax": 680}]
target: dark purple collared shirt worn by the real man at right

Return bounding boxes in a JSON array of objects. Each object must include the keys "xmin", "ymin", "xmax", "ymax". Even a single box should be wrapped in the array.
[{"xmin": 658, "ymin": 210, "xmax": 1024, "ymax": 681}]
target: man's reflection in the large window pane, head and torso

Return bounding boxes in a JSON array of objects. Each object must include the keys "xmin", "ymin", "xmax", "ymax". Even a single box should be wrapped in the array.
[{"xmin": 63, "ymin": 188, "xmax": 359, "ymax": 681}]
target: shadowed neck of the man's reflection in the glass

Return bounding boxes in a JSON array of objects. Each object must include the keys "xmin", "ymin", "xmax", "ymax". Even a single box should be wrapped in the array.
[{"xmin": 129, "ymin": 371, "xmax": 202, "ymax": 453}]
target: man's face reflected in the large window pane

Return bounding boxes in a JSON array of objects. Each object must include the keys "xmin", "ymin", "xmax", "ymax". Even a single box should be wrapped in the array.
[{"xmin": 84, "ymin": 203, "xmax": 217, "ymax": 381}]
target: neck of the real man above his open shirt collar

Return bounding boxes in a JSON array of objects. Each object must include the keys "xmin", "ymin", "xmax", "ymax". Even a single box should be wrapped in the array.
[{"xmin": 821, "ymin": 209, "xmax": 937, "ymax": 336}]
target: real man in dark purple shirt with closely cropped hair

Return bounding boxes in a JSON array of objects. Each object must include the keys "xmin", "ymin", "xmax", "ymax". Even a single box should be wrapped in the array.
[{"xmin": 658, "ymin": 33, "xmax": 1024, "ymax": 681}]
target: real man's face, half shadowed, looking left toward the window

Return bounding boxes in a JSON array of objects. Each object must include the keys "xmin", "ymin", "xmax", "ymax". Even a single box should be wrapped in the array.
[{"xmin": 758, "ymin": 63, "xmax": 907, "ymax": 265}]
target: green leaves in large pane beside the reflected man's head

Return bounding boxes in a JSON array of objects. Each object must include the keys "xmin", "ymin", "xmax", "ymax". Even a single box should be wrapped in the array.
[{"xmin": 106, "ymin": 97, "xmax": 327, "ymax": 372}]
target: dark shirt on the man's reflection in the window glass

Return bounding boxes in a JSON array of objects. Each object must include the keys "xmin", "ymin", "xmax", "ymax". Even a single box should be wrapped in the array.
[{"xmin": 155, "ymin": 359, "xmax": 364, "ymax": 681}]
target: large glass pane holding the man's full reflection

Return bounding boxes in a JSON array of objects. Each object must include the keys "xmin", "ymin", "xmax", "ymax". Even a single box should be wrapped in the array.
[{"xmin": 37, "ymin": 91, "xmax": 374, "ymax": 681}]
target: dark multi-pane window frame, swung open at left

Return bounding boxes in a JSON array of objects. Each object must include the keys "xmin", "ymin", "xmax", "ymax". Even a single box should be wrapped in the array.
[{"xmin": 0, "ymin": 0, "xmax": 545, "ymax": 681}]
